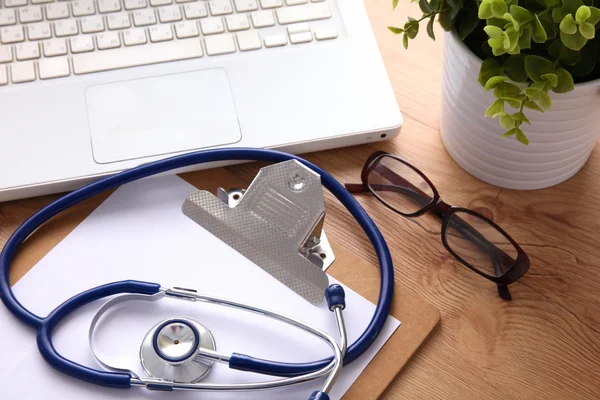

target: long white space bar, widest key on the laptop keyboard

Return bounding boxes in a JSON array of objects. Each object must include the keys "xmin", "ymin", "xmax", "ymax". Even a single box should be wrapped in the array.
[{"xmin": 73, "ymin": 35, "xmax": 203, "ymax": 75}]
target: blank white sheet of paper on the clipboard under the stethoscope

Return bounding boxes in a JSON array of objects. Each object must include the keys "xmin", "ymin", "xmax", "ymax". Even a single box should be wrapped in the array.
[{"xmin": 0, "ymin": 176, "xmax": 399, "ymax": 400}]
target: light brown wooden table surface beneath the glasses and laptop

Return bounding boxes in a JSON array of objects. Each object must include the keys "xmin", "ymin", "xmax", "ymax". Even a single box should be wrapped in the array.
[{"xmin": 0, "ymin": 0, "xmax": 600, "ymax": 399}]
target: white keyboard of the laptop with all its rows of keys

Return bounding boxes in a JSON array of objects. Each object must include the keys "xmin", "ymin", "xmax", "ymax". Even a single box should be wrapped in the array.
[{"xmin": 0, "ymin": 0, "xmax": 338, "ymax": 85}]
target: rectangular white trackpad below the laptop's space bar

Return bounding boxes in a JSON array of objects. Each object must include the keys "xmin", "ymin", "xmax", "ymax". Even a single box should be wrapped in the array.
[{"xmin": 85, "ymin": 68, "xmax": 242, "ymax": 164}]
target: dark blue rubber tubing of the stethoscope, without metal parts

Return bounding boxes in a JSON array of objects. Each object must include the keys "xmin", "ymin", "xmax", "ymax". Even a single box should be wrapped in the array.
[{"xmin": 0, "ymin": 148, "xmax": 394, "ymax": 388}]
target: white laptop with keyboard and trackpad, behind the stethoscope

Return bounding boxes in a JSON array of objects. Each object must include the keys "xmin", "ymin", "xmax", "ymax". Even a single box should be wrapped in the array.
[{"xmin": 0, "ymin": 0, "xmax": 402, "ymax": 201}]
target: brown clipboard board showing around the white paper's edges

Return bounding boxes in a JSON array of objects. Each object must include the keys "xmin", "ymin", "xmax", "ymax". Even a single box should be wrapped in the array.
[{"xmin": 10, "ymin": 168, "xmax": 440, "ymax": 400}]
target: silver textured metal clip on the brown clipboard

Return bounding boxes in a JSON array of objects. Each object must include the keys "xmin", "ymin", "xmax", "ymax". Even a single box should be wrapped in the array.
[{"xmin": 183, "ymin": 160, "xmax": 335, "ymax": 304}]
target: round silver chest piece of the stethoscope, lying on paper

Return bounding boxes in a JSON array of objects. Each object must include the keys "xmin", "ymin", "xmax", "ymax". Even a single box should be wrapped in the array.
[{"xmin": 140, "ymin": 317, "xmax": 216, "ymax": 383}]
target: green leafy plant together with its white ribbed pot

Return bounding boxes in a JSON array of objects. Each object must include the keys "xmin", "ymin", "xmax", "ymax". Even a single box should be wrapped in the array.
[{"xmin": 389, "ymin": 0, "xmax": 600, "ymax": 189}]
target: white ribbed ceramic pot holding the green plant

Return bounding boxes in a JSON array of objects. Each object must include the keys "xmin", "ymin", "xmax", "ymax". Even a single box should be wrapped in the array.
[{"xmin": 440, "ymin": 32, "xmax": 600, "ymax": 189}]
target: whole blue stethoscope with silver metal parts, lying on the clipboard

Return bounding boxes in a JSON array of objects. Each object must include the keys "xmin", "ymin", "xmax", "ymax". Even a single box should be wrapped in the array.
[{"xmin": 0, "ymin": 148, "xmax": 394, "ymax": 400}]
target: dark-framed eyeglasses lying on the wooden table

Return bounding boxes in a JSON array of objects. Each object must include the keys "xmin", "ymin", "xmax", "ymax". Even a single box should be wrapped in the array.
[{"xmin": 346, "ymin": 151, "xmax": 530, "ymax": 300}]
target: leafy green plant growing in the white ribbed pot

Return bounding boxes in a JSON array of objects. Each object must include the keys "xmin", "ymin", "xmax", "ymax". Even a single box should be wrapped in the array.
[{"xmin": 388, "ymin": 0, "xmax": 600, "ymax": 144}]
